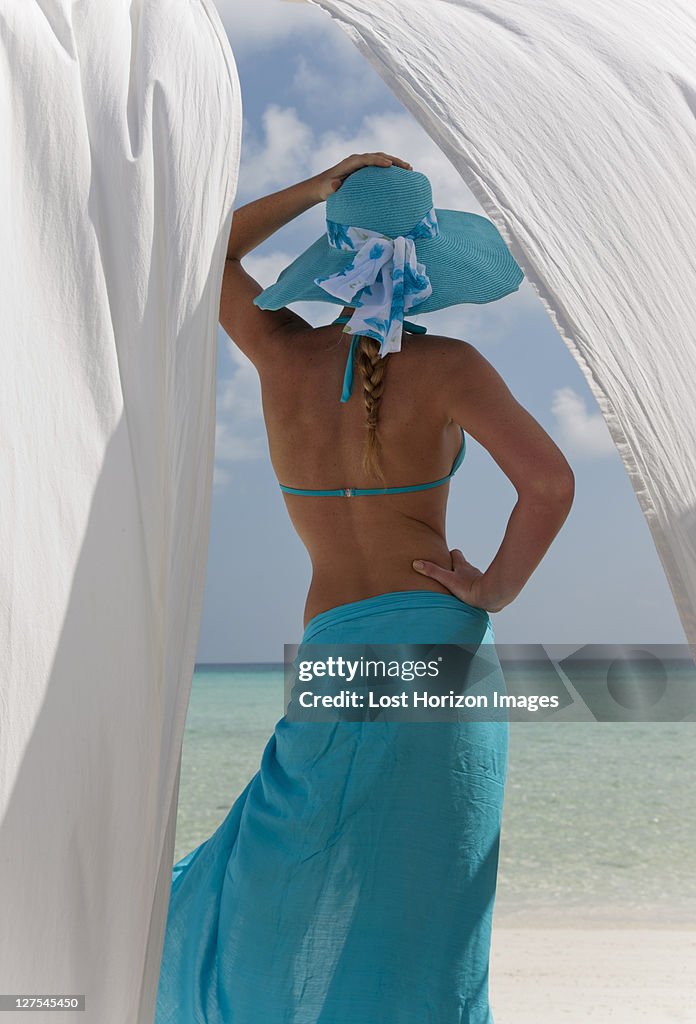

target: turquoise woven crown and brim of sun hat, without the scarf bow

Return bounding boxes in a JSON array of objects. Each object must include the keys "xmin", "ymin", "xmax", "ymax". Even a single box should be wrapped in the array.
[{"xmin": 254, "ymin": 165, "xmax": 524, "ymax": 314}]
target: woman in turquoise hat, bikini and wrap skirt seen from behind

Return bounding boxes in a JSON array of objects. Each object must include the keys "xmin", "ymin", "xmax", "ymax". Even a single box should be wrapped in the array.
[{"xmin": 157, "ymin": 153, "xmax": 573, "ymax": 1024}]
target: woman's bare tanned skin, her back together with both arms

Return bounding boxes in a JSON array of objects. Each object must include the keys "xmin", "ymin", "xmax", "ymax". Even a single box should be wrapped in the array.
[{"xmin": 220, "ymin": 200, "xmax": 574, "ymax": 623}]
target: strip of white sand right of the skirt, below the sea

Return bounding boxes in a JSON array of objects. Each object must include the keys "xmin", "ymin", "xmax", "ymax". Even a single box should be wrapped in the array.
[{"xmin": 489, "ymin": 923, "xmax": 696, "ymax": 1024}]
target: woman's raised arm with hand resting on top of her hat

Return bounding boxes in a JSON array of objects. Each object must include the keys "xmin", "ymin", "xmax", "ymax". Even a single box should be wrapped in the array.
[{"xmin": 220, "ymin": 153, "xmax": 411, "ymax": 367}]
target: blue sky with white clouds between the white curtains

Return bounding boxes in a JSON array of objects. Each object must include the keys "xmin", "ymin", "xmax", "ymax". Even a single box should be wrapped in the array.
[{"xmin": 197, "ymin": 0, "xmax": 685, "ymax": 663}]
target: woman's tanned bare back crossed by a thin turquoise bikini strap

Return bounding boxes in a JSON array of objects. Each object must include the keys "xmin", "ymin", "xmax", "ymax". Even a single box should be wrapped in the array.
[{"xmin": 260, "ymin": 325, "xmax": 466, "ymax": 624}]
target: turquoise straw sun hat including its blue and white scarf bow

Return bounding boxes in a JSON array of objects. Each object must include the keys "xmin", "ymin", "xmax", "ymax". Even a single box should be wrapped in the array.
[{"xmin": 254, "ymin": 165, "xmax": 524, "ymax": 401}]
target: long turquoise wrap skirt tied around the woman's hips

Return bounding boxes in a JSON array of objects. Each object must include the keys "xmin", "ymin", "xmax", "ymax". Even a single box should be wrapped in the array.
[{"xmin": 156, "ymin": 591, "xmax": 508, "ymax": 1024}]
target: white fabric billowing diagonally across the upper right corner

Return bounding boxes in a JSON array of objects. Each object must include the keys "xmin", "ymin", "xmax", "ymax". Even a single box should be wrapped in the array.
[{"xmin": 300, "ymin": 0, "xmax": 696, "ymax": 651}]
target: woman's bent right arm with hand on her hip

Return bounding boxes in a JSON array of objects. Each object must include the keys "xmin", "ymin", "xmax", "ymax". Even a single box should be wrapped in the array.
[{"xmin": 414, "ymin": 342, "xmax": 574, "ymax": 611}]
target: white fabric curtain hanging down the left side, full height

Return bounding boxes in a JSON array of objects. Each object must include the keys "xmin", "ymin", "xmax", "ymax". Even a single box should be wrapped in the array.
[{"xmin": 0, "ymin": 0, "xmax": 242, "ymax": 1024}]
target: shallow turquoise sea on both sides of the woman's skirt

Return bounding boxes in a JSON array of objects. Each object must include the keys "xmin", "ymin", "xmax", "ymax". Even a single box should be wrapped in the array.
[{"xmin": 175, "ymin": 665, "xmax": 696, "ymax": 925}]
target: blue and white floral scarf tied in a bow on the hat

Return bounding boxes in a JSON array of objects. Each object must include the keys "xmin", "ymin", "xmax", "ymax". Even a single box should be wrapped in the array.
[{"xmin": 314, "ymin": 208, "xmax": 440, "ymax": 382}]
